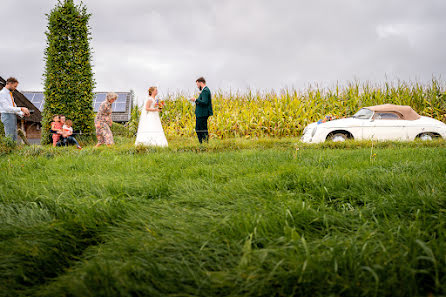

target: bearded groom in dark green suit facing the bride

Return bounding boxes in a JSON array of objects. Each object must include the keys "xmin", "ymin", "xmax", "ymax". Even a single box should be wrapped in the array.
[{"xmin": 191, "ymin": 77, "xmax": 213, "ymax": 143}]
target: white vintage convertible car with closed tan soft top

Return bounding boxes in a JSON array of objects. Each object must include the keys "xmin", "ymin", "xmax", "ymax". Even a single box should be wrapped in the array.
[{"xmin": 302, "ymin": 104, "xmax": 446, "ymax": 143}]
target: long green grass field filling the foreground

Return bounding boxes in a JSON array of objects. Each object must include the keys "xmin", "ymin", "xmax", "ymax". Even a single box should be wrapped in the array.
[{"xmin": 0, "ymin": 139, "xmax": 446, "ymax": 297}]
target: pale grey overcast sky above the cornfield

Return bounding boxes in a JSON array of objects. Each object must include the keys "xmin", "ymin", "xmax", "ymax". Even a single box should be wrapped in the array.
[{"xmin": 0, "ymin": 0, "xmax": 446, "ymax": 101}]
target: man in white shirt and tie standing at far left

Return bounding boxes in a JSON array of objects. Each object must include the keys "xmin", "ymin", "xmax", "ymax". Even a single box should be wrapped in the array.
[{"xmin": 0, "ymin": 77, "xmax": 30, "ymax": 141}]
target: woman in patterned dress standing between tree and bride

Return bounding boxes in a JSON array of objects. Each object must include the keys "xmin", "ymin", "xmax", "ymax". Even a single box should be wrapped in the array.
[{"xmin": 94, "ymin": 93, "xmax": 118, "ymax": 147}]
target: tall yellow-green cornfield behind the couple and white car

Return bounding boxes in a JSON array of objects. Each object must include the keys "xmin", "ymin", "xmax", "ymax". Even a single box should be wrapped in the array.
[{"xmin": 157, "ymin": 78, "xmax": 446, "ymax": 138}]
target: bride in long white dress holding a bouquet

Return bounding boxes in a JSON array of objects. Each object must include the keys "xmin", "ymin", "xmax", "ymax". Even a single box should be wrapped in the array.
[{"xmin": 135, "ymin": 87, "xmax": 167, "ymax": 147}]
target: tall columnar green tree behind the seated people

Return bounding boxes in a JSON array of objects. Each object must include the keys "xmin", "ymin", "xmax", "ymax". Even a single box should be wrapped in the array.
[{"xmin": 42, "ymin": 0, "xmax": 95, "ymax": 143}]
